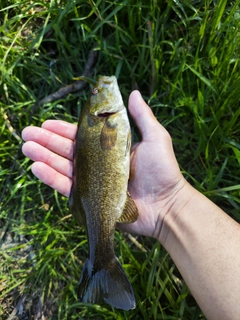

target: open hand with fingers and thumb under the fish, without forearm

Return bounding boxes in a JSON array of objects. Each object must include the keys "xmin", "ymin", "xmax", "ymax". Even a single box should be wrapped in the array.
[{"xmin": 22, "ymin": 91, "xmax": 184, "ymax": 238}]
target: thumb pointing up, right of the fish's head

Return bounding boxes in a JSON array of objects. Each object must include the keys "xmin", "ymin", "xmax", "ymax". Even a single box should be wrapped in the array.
[{"xmin": 128, "ymin": 90, "xmax": 166, "ymax": 141}]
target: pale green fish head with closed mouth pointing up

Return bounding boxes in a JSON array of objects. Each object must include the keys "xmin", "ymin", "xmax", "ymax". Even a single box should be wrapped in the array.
[{"xmin": 89, "ymin": 76, "xmax": 125, "ymax": 118}]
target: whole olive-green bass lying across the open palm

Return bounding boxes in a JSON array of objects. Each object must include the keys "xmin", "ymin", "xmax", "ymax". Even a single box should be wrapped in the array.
[{"xmin": 69, "ymin": 76, "xmax": 138, "ymax": 310}]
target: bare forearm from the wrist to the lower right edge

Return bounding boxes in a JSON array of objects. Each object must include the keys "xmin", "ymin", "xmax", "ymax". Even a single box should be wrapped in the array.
[{"xmin": 159, "ymin": 184, "xmax": 240, "ymax": 320}]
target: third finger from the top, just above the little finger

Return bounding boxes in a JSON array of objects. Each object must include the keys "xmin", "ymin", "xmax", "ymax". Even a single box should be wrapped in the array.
[{"xmin": 22, "ymin": 141, "xmax": 72, "ymax": 178}]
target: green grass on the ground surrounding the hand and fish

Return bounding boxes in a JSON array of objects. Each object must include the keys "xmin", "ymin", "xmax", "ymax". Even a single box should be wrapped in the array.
[{"xmin": 0, "ymin": 0, "xmax": 240, "ymax": 320}]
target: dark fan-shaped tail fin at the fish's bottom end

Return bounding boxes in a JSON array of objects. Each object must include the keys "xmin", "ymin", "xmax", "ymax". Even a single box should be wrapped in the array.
[{"xmin": 78, "ymin": 257, "xmax": 136, "ymax": 310}]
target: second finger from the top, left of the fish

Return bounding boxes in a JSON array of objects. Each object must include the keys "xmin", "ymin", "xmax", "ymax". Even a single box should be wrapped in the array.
[{"xmin": 22, "ymin": 126, "xmax": 73, "ymax": 160}]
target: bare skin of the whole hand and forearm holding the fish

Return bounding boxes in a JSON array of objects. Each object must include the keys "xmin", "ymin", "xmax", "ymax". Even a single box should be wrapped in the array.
[{"xmin": 22, "ymin": 91, "xmax": 240, "ymax": 320}]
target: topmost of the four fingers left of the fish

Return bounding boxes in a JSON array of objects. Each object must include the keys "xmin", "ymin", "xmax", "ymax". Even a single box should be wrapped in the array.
[{"xmin": 42, "ymin": 120, "xmax": 77, "ymax": 140}]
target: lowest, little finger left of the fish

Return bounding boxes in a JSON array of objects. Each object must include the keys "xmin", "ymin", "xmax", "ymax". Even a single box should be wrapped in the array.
[{"xmin": 31, "ymin": 162, "xmax": 72, "ymax": 197}]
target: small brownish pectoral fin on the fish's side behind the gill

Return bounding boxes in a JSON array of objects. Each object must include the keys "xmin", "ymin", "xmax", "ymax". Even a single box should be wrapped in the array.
[{"xmin": 100, "ymin": 120, "xmax": 117, "ymax": 150}]
